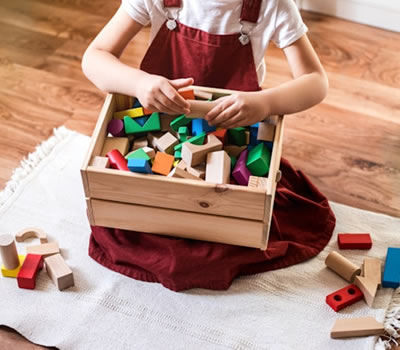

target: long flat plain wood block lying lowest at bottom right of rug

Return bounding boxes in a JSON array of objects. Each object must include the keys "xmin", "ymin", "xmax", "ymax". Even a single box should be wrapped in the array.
[{"xmin": 331, "ymin": 317, "xmax": 385, "ymax": 339}]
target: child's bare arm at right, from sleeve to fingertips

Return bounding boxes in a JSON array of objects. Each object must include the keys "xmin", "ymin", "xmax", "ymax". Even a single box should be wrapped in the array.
[{"xmin": 206, "ymin": 35, "xmax": 328, "ymax": 128}]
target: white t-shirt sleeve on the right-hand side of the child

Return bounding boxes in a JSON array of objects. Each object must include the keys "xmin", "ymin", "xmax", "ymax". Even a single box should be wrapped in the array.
[{"xmin": 271, "ymin": 0, "xmax": 308, "ymax": 48}]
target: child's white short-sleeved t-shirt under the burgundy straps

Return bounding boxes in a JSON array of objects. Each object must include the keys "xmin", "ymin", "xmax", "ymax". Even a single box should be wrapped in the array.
[{"xmin": 122, "ymin": 0, "xmax": 307, "ymax": 85}]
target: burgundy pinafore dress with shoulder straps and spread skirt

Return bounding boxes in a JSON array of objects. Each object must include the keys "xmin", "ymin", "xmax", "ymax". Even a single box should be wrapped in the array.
[{"xmin": 89, "ymin": 0, "xmax": 335, "ymax": 291}]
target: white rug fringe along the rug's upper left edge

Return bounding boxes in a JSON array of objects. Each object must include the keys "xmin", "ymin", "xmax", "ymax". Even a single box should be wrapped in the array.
[{"xmin": 0, "ymin": 126, "xmax": 76, "ymax": 208}]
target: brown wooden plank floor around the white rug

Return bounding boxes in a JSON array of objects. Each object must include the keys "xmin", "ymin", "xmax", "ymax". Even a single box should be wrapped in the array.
[{"xmin": 0, "ymin": 0, "xmax": 400, "ymax": 349}]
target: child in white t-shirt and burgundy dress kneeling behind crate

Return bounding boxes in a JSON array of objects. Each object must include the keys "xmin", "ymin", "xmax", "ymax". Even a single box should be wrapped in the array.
[{"xmin": 82, "ymin": 0, "xmax": 335, "ymax": 290}]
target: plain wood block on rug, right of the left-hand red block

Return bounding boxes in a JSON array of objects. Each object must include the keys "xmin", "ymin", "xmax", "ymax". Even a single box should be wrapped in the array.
[{"xmin": 44, "ymin": 254, "xmax": 74, "ymax": 290}]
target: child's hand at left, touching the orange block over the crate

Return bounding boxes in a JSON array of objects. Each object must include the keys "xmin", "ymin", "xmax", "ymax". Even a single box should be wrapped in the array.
[{"xmin": 136, "ymin": 74, "xmax": 193, "ymax": 114}]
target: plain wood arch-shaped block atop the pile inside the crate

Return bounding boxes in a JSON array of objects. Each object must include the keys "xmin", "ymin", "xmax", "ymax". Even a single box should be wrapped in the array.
[{"xmin": 182, "ymin": 135, "xmax": 223, "ymax": 166}]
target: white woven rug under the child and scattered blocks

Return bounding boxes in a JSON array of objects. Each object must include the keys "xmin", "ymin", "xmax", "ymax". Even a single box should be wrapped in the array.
[{"xmin": 0, "ymin": 128, "xmax": 400, "ymax": 350}]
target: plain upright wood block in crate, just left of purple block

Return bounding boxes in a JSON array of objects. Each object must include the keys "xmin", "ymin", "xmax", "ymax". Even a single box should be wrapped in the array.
[{"xmin": 206, "ymin": 151, "xmax": 231, "ymax": 184}]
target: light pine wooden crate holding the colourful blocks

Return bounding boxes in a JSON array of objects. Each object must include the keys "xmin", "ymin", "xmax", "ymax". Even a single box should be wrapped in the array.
[{"xmin": 81, "ymin": 87, "xmax": 283, "ymax": 250}]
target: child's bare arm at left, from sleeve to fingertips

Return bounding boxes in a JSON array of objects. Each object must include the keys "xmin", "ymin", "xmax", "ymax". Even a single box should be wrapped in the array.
[{"xmin": 82, "ymin": 8, "xmax": 193, "ymax": 114}]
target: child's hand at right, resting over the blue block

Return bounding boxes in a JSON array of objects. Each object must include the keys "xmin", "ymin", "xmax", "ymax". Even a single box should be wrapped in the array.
[{"xmin": 205, "ymin": 92, "xmax": 269, "ymax": 129}]
